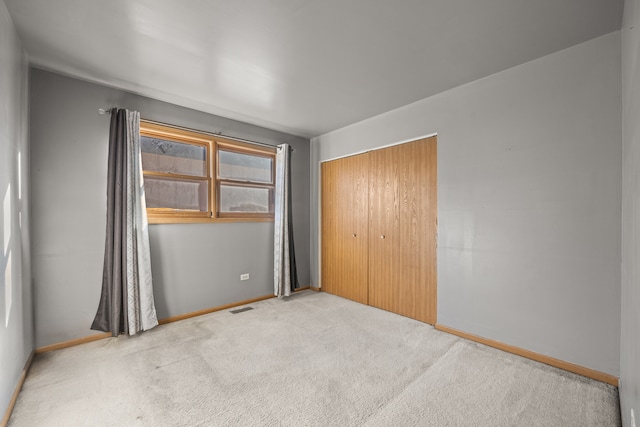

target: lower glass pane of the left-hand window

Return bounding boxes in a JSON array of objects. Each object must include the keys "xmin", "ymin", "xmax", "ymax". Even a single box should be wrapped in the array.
[{"xmin": 144, "ymin": 176, "xmax": 208, "ymax": 212}]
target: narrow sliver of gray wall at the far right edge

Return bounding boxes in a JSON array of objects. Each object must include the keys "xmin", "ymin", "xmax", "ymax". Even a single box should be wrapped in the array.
[{"xmin": 620, "ymin": 0, "xmax": 640, "ymax": 426}]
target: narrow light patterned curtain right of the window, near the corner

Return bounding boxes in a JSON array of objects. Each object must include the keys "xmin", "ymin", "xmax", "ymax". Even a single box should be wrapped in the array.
[{"xmin": 273, "ymin": 144, "xmax": 300, "ymax": 297}]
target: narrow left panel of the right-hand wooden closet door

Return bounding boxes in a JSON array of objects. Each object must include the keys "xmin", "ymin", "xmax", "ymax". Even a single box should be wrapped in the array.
[{"xmin": 369, "ymin": 146, "xmax": 400, "ymax": 313}]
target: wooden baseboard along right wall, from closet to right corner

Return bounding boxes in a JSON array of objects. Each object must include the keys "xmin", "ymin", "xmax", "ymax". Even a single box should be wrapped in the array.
[{"xmin": 435, "ymin": 324, "xmax": 619, "ymax": 387}]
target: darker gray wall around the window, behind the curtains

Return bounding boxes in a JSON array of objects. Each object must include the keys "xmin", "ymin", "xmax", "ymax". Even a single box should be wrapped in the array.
[{"xmin": 31, "ymin": 69, "xmax": 310, "ymax": 347}]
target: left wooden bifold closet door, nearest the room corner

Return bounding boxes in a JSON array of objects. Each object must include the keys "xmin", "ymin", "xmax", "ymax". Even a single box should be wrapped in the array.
[{"xmin": 321, "ymin": 153, "xmax": 369, "ymax": 304}]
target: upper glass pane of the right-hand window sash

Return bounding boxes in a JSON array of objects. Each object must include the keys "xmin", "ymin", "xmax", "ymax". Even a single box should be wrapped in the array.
[{"xmin": 218, "ymin": 150, "xmax": 273, "ymax": 183}]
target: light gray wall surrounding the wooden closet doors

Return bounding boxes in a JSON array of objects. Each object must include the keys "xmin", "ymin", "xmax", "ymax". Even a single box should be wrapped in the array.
[{"xmin": 311, "ymin": 32, "xmax": 621, "ymax": 375}]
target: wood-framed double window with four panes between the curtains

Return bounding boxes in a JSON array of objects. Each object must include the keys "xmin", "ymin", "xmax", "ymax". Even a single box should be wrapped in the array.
[{"xmin": 140, "ymin": 121, "xmax": 275, "ymax": 223}]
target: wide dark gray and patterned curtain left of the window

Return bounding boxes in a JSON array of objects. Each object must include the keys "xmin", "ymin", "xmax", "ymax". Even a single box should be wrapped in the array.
[{"xmin": 91, "ymin": 108, "xmax": 158, "ymax": 337}]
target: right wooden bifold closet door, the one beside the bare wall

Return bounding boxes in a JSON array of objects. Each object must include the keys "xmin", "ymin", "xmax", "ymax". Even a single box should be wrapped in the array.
[{"xmin": 369, "ymin": 136, "xmax": 437, "ymax": 324}]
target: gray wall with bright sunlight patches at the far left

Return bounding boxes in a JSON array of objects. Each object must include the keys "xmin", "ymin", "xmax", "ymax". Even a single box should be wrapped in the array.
[{"xmin": 0, "ymin": 1, "xmax": 33, "ymax": 418}]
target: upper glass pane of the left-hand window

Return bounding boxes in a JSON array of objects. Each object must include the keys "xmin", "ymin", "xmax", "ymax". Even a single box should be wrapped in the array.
[{"xmin": 140, "ymin": 136, "xmax": 207, "ymax": 176}]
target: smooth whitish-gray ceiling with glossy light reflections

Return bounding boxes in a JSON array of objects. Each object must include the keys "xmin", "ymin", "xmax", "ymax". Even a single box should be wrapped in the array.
[{"xmin": 5, "ymin": 0, "xmax": 623, "ymax": 137}]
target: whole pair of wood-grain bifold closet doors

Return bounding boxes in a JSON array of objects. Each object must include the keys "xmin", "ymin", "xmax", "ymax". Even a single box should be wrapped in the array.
[{"xmin": 322, "ymin": 136, "xmax": 437, "ymax": 324}]
